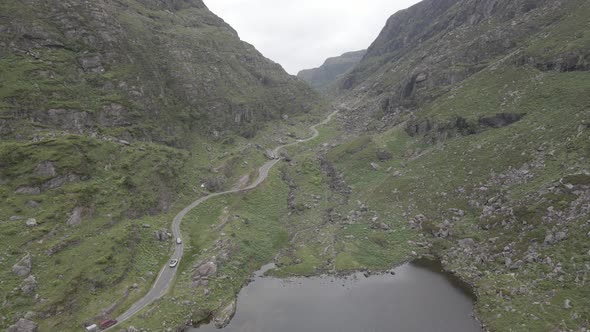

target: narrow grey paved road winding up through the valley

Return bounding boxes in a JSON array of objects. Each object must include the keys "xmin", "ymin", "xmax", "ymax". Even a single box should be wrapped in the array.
[{"xmin": 107, "ymin": 111, "xmax": 338, "ymax": 330}]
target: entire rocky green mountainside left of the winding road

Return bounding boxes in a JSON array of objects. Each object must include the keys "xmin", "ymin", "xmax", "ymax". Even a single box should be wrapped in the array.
[{"xmin": 0, "ymin": 0, "xmax": 321, "ymax": 331}]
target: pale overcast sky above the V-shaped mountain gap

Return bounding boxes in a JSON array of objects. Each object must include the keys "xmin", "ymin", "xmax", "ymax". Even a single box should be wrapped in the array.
[{"xmin": 205, "ymin": 0, "xmax": 418, "ymax": 74}]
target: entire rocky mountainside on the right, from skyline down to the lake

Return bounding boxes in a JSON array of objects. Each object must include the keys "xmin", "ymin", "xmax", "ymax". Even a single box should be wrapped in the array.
[{"xmin": 328, "ymin": 0, "xmax": 590, "ymax": 331}]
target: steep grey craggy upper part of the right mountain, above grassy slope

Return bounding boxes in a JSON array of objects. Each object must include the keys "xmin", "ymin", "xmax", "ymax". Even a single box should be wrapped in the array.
[{"xmin": 340, "ymin": 0, "xmax": 590, "ymax": 131}]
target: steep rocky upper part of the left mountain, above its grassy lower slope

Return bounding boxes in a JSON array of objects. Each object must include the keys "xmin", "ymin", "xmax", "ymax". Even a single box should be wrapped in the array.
[{"xmin": 0, "ymin": 0, "xmax": 317, "ymax": 145}]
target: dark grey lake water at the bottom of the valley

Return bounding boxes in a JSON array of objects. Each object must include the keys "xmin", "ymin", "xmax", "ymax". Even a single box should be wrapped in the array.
[{"xmin": 197, "ymin": 261, "xmax": 482, "ymax": 332}]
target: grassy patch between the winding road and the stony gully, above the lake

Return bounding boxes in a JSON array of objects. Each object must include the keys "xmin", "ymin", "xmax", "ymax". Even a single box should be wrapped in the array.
[{"xmin": 123, "ymin": 158, "xmax": 294, "ymax": 327}]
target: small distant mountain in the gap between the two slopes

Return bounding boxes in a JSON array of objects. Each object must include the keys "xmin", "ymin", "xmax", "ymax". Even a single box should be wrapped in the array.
[{"xmin": 297, "ymin": 50, "xmax": 367, "ymax": 91}]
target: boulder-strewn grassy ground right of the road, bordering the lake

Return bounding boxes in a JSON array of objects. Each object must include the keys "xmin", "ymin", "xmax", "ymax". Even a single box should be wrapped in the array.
[{"xmin": 130, "ymin": 68, "xmax": 590, "ymax": 331}]
